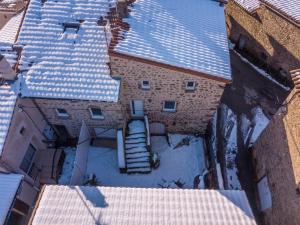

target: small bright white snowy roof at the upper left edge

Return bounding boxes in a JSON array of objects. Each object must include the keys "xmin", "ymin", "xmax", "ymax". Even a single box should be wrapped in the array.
[{"xmin": 0, "ymin": 11, "xmax": 24, "ymax": 67}]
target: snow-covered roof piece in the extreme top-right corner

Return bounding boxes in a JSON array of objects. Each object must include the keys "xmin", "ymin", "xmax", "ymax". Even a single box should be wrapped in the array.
[{"xmin": 262, "ymin": 0, "xmax": 300, "ymax": 23}]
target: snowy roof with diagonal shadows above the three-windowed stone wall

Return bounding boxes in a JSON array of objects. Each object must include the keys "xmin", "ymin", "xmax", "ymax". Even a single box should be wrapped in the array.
[{"xmin": 113, "ymin": 0, "xmax": 231, "ymax": 80}]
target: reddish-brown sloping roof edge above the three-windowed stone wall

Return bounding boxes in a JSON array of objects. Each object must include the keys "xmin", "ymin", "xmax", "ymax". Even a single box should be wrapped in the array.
[{"xmin": 108, "ymin": 49, "xmax": 232, "ymax": 84}]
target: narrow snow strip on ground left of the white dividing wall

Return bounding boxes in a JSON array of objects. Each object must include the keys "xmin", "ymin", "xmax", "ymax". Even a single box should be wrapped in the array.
[{"xmin": 58, "ymin": 147, "xmax": 76, "ymax": 185}]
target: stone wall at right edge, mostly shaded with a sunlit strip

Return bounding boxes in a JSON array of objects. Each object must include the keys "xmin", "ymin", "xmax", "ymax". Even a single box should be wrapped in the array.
[{"xmin": 254, "ymin": 89, "xmax": 300, "ymax": 225}]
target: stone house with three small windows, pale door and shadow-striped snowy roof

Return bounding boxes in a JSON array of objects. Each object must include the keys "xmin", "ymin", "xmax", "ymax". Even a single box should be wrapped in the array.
[{"xmin": 109, "ymin": 0, "xmax": 231, "ymax": 134}]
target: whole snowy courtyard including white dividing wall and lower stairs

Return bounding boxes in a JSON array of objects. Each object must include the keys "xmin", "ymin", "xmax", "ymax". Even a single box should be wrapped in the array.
[{"xmin": 59, "ymin": 119, "xmax": 209, "ymax": 189}]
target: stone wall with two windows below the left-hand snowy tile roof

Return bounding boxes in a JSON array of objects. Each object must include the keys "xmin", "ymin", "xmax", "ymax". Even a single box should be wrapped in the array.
[{"xmin": 35, "ymin": 99, "xmax": 124, "ymax": 137}]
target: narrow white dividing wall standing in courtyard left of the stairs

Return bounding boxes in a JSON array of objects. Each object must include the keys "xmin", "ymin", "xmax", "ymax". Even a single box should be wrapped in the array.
[{"xmin": 70, "ymin": 121, "xmax": 91, "ymax": 185}]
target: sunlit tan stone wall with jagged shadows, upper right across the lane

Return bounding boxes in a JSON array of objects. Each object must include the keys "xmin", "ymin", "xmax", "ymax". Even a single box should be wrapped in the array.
[{"xmin": 225, "ymin": 0, "xmax": 300, "ymax": 79}]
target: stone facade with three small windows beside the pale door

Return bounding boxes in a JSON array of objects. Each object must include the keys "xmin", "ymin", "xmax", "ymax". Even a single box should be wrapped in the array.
[{"xmin": 111, "ymin": 56, "xmax": 225, "ymax": 133}]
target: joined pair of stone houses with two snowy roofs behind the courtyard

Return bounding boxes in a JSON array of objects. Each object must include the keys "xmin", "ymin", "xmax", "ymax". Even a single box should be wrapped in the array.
[{"xmin": 17, "ymin": 0, "xmax": 231, "ymax": 139}]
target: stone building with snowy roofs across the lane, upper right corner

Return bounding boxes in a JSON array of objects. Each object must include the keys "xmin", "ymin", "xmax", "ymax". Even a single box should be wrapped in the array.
[{"xmin": 225, "ymin": 0, "xmax": 300, "ymax": 84}]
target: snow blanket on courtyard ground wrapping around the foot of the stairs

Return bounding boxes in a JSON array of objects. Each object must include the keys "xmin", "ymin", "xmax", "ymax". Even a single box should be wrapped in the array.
[{"xmin": 86, "ymin": 134, "xmax": 206, "ymax": 188}]
